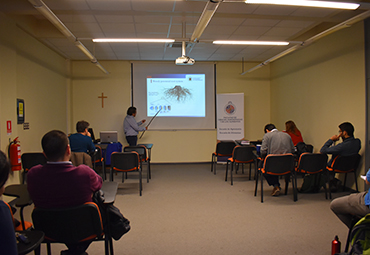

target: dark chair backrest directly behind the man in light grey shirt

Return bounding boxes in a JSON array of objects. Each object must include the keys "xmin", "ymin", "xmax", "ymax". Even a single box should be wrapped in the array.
[{"xmin": 263, "ymin": 153, "xmax": 295, "ymax": 175}]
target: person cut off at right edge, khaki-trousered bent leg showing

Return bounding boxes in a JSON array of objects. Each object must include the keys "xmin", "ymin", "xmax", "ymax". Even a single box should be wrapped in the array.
[{"xmin": 330, "ymin": 169, "xmax": 370, "ymax": 228}]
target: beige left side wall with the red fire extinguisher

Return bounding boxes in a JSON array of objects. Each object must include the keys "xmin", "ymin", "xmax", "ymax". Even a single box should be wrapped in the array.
[{"xmin": 0, "ymin": 13, "xmax": 69, "ymax": 184}]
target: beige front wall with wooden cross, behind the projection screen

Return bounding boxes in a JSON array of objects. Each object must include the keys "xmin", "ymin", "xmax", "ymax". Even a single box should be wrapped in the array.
[{"xmin": 70, "ymin": 61, "xmax": 270, "ymax": 163}]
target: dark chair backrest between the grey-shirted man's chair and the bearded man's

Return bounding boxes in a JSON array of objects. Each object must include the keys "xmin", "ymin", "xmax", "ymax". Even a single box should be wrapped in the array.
[{"xmin": 296, "ymin": 152, "xmax": 328, "ymax": 174}]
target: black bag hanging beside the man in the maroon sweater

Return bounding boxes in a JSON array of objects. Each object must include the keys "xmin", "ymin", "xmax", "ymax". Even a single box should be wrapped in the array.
[{"xmin": 93, "ymin": 190, "xmax": 131, "ymax": 241}]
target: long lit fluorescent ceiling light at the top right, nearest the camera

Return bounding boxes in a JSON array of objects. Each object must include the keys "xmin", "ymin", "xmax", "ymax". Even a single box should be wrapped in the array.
[{"xmin": 245, "ymin": 0, "xmax": 360, "ymax": 10}]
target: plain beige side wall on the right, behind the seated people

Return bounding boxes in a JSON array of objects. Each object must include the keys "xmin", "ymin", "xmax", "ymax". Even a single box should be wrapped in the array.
[{"xmin": 271, "ymin": 22, "xmax": 366, "ymax": 189}]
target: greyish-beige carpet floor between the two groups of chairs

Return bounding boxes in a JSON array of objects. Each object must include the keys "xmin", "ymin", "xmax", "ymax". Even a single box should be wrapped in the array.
[{"xmin": 21, "ymin": 164, "xmax": 348, "ymax": 255}]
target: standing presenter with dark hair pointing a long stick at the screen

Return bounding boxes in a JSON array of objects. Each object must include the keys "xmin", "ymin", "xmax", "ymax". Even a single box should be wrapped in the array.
[{"xmin": 123, "ymin": 106, "xmax": 148, "ymax": 146}]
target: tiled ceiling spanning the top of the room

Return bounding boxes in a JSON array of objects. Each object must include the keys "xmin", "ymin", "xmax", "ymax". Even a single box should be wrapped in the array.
[{"xmin": 0, "ymin": 0, "xmax": 370, "ymax": 62}]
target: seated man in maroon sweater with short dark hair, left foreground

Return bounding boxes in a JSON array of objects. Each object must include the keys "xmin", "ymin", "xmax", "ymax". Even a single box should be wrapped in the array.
[{"xmin": 27, "ymin": 130, "xmax": 102, "ymax": 255}]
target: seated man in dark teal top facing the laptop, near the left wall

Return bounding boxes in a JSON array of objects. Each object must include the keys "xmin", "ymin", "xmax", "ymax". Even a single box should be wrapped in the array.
[{"xmin": 68, "ymin": 120, "xmax": 95, "ymax": 153}]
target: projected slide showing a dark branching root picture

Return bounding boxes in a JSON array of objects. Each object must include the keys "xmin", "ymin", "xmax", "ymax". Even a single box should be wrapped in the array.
[{"xmin": 146, "ymin": 74, "xmax": 206, "ymax": 117}]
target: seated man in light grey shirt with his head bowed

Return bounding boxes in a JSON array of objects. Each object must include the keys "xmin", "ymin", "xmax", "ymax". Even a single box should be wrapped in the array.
[{"xmin": 261, "ymin": 124, "xmax": 294, "ymax": 196}]
